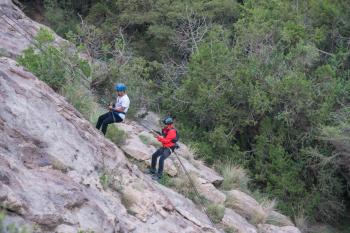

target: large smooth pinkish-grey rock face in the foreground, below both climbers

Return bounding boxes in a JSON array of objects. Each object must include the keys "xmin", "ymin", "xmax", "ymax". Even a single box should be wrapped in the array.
[{"xmin": 0, "ymin": 58, "xmax": 216, "ymax": 232}]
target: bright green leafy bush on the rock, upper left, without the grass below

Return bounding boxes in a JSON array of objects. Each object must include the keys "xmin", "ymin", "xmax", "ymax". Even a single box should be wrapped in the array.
[{"xmin": 18, "ymin": 28, "xmax": 91, "ymax": 92}]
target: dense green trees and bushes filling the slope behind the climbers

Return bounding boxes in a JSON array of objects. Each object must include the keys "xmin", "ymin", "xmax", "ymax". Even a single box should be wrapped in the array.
[{"xmin": 20, "ymin": 0, "xmax": 350, "ymax": 226}]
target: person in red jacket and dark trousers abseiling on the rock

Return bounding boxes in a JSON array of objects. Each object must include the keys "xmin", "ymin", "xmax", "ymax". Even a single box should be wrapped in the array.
[{"xmin": 149, "ymin": 116, "xmax": 178, "ymax": 180}]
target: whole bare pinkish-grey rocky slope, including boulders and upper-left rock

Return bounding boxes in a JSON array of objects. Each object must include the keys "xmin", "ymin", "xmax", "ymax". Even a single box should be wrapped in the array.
[{"xmin": 0, "ymin": 0, "xmax": 299, "ymax": 233}]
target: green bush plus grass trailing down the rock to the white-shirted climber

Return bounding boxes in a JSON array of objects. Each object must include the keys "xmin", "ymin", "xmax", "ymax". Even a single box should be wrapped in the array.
[{"xmin": 18, "ymin": 28, "xmax": 99, "ymax": 120}]
